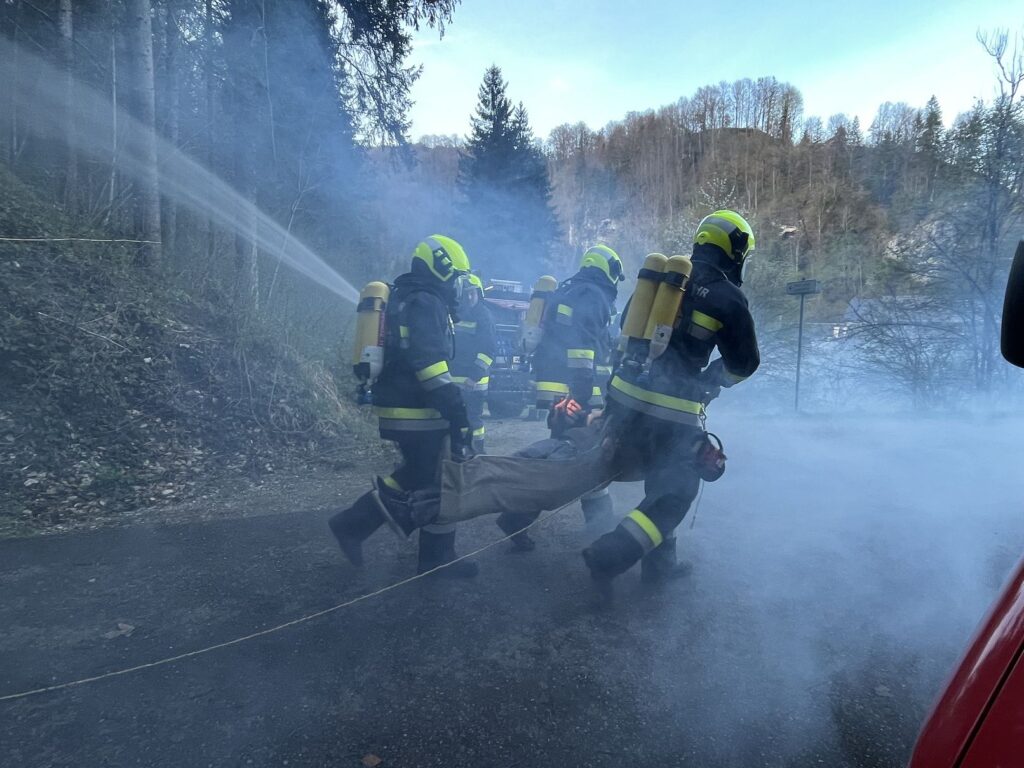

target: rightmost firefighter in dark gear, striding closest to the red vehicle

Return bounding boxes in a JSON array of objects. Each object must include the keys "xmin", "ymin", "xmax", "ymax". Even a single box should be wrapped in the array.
[{"xmin": 583, "ymin": 211, "xmax": 760, "ymax": 583}]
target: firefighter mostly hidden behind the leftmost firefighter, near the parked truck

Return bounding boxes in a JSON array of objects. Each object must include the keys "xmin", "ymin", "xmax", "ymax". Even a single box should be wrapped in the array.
[{"xmin": 452, "ymin": 274, "xmax": 497, "ymax": 454}]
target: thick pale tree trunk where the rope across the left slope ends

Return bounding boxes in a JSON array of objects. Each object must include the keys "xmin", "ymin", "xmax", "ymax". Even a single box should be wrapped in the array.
[{"xmin": 128, "ymin": 0, "xmax": 160, "ymax": 265}]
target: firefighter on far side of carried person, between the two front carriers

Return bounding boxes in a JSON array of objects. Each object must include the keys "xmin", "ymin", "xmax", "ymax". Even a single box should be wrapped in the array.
[{"xmin": 498, "ymin": 246, "xmax": 623, "ymax": 551}]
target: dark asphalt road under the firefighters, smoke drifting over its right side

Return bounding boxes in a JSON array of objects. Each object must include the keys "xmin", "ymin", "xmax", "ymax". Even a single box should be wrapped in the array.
[{"xmin": 0, "ymin": 415, "xmax": 1024, "ymax": 768}]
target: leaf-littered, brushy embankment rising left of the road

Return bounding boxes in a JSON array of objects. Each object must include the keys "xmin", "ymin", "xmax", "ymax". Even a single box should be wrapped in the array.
[{"xmin": 0, "ymin": 168, "xmax": 380, "ymax": 537}]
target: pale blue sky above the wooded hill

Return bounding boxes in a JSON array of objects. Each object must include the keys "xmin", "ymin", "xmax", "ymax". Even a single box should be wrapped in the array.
[{"xmin": 411, "ymin": 0, "xmax": 1024, "ymax": 138}]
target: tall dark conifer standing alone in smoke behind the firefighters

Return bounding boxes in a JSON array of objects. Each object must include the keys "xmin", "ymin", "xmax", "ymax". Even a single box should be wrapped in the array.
[{"xmin": 456, "ymin": 67, "xmax": 557, "ymax": 281}]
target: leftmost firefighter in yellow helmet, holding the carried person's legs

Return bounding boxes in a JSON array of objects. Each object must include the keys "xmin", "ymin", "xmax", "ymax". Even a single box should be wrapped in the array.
[{"xmin": 330, "ymin": 234, "xmax": 482, "ymax": 578}]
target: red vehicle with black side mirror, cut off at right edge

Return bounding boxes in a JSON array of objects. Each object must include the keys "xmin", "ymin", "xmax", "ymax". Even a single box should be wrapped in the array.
[{"xmin": 910, "ymin": 241, "xmax": 1024, "ymax": 768}]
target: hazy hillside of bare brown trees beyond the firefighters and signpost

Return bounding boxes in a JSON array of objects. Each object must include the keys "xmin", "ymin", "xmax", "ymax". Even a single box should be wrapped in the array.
[{"xmin": 401, "ymin": 60, "xmax": 1024, "ymax": 409}]
